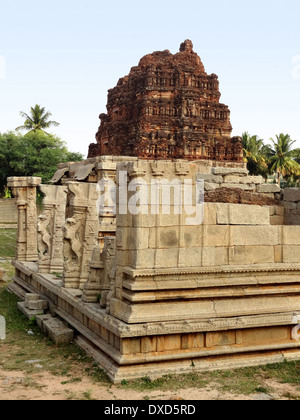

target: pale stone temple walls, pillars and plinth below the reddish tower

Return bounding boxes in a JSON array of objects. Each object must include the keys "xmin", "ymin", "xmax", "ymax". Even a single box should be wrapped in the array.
[{"xmin": 8, "ymin": 157, "xmax": 300, "ymax": 382}]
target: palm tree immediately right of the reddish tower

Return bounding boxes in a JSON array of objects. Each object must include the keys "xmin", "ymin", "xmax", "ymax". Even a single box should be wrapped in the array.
[{"xmin": 242, "ymin": 132, "xmax": 269, "ymax": 178}]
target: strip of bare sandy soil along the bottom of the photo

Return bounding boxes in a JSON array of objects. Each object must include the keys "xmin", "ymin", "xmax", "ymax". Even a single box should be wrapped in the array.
[{"xmin": 0, "ymin": 369, "xmax": 300, "ymax": 401}]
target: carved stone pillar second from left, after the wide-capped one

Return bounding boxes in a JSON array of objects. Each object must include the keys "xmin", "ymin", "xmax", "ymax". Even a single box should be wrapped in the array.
[{"xmin": 38, "ymin": 185, "xmax": 68, "ymax": 273}]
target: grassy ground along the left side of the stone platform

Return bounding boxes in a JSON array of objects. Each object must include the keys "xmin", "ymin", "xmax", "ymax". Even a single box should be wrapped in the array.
[{"xmin": 0, "ymin": 286, "xmax": 110, "ymax": 384}]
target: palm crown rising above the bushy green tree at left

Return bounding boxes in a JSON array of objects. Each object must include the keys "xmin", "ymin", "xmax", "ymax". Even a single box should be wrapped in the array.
[{"xmin": 16, "ymin": 105, "xmax": 59, "ymax": 134}]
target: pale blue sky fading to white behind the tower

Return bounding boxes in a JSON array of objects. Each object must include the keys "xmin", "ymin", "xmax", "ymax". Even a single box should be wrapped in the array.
[{"xmin": 0, "ymin": 0, "xmax": 300, "ymax": 155}]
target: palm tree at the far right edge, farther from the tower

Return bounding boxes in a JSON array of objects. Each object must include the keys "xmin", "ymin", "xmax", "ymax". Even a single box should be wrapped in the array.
[{"xmin": 270, "ymin": 133, "xmax": 300, "ymax": 186}]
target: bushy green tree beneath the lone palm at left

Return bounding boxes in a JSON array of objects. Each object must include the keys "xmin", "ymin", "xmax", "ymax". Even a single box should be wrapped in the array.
[{"xmin": 0, "ymin": 130, "xmax": 84, "ymax": 194}]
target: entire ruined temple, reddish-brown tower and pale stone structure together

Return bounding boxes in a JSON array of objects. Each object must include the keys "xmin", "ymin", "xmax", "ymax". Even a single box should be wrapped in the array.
[{"xmin": 8, "ymin": 41, "xmax": 300, "ymax": 383}]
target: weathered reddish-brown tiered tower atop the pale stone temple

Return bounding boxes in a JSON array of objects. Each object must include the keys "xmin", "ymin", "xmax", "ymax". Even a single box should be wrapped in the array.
[{"xmin": 89, "ymin": 40, "xmax": 243, "ymax": 162}]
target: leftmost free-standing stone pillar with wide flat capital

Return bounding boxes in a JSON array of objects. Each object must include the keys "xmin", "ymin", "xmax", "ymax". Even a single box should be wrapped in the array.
[{"xmin": 7, "ymin": 177, "xmax": 42, "ymax": 262}]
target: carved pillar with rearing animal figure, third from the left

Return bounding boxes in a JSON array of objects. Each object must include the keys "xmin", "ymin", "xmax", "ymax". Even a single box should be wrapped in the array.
[{"xmin": 63, "ymin": 182, "xmax": 100, "ymax": 289}]
